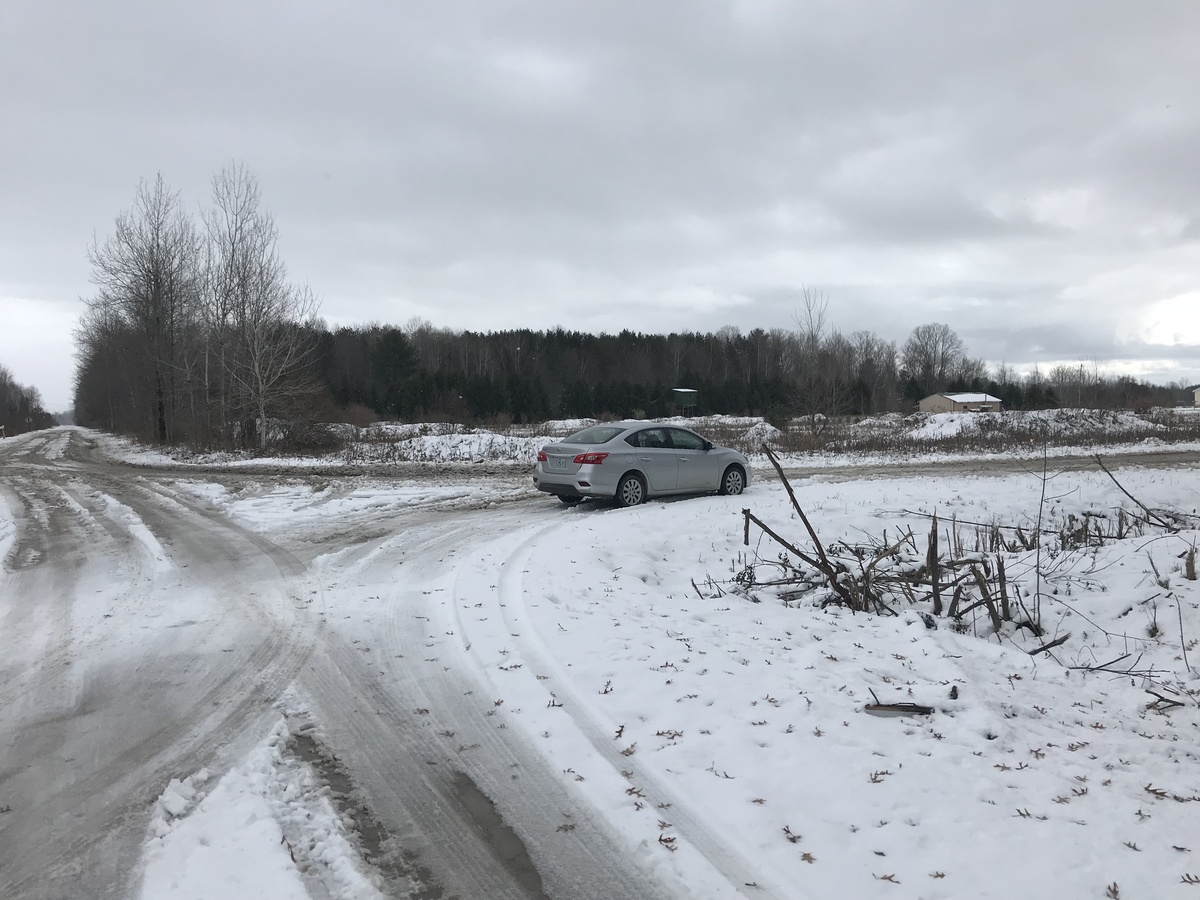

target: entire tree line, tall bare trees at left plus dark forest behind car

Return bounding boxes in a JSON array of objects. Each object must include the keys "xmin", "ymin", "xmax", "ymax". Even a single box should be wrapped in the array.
[{"xmin": 72, "ymin": 166, "xmax": 1184, "ymax": 448}]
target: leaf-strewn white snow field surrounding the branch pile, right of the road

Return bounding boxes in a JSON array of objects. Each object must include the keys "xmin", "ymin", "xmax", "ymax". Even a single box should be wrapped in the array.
[{"xmin": 144, "ymin": 441, "xmax": 1200, "ymax": 900}]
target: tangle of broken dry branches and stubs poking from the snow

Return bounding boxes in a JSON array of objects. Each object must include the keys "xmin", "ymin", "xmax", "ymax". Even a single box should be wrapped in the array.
[{"xmin": 695, "ymin": 446, "xmax": 1198, "ymax": 653}]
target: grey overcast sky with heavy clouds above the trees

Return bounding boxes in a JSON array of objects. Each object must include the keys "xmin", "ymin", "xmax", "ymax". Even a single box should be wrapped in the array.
[{"xmin": 0, "ymin": 0, "xmax": 1200, "ymax": 410}]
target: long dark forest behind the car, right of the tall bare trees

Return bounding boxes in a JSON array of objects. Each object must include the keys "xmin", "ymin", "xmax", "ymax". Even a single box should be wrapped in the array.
[{"xmin": 317, "ymin": 314, "xmax": 1186, "ymax": 422}]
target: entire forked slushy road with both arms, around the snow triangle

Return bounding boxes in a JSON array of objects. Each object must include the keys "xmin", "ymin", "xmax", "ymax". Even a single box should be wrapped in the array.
[{"xmin": 0, "ymin": 431, "xmax": 696, "ymax": 898}]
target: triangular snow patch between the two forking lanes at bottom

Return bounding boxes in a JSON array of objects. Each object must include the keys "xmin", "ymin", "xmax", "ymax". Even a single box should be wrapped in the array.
[{"xmin": 139, "ymin": 721, "xmax": 383, "ymax": 900}]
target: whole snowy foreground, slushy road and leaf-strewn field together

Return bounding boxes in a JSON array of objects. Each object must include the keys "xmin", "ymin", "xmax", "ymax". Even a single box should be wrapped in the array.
[{"xmin": 0, "ymin": 430, "xmax": 1200, "ymax": 900}]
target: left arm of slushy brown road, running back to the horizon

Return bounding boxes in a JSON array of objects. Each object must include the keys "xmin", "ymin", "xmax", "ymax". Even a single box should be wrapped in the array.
[{"xmin": 0, "ymin": 432, "xmax": 314, "ymax": 898}]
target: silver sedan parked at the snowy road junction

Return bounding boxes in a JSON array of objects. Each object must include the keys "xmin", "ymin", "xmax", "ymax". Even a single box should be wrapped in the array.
[{"xmin": 533, "ymin": 422, "xmax": 750, "ymax": 506}]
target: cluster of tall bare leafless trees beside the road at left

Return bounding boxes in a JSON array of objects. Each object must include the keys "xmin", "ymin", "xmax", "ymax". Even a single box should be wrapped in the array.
[{"xmin": 74, "ymin": 164, "xmax": 320, "ymax": 446}]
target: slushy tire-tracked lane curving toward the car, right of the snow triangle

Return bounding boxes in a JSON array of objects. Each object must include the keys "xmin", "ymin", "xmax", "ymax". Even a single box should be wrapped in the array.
[{"xmin": 301, "ymin": 510, "xmax": 668, "ymax": 900}]
